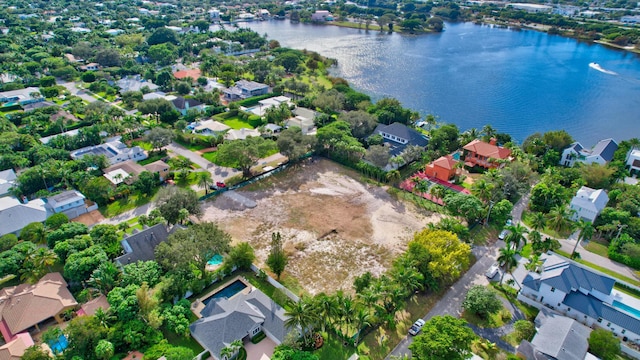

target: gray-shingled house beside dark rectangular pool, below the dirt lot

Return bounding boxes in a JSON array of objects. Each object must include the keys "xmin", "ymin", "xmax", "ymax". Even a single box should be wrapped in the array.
[{"xmin": 189, "ymin": 287, "xmax": 288, "ymax": 360}]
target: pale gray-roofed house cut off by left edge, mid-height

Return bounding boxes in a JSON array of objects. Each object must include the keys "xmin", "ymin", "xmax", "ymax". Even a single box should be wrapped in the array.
[{"xmin": 0, "ymin": 196, "xmax": 51, "ymax": 236}]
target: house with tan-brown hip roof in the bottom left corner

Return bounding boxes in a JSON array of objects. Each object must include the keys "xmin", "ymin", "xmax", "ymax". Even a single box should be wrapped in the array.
[{"xmin": 0, "ymin": 272, "xmax": 78, "ymax": 342}]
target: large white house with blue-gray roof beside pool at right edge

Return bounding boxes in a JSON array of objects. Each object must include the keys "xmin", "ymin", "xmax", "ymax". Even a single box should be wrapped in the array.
[{"xmin": 518, "ymin": 254, "xmax": 640, "ymax": 344}]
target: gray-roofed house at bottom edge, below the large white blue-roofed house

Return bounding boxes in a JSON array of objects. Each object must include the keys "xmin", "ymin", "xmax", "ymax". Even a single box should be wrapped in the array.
[{"xmin": 517, "ymin": 308, "xmax": 591, "ymax": 360}]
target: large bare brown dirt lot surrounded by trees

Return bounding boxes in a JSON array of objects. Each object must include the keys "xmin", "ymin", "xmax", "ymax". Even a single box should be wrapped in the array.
[{"xmin": 202, "ymin": 160, "xmax": 439, "ymax": 294}]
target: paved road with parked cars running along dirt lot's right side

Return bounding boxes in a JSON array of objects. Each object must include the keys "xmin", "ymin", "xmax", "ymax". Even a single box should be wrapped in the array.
[{"xmin": 386, "ymin": 241, "xmax": 504, "ymax": 359}]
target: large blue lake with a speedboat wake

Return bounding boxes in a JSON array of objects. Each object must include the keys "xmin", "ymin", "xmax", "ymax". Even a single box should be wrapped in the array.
[{"xmin": 242, "ymin": 20, "xmax": 640, "ymax": 147}]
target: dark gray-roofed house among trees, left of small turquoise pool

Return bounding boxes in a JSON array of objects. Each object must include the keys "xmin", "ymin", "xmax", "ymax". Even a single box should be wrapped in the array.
[{"xmin": 115, "ymin": 224, "xmax": 169, "ymax": 266}]
